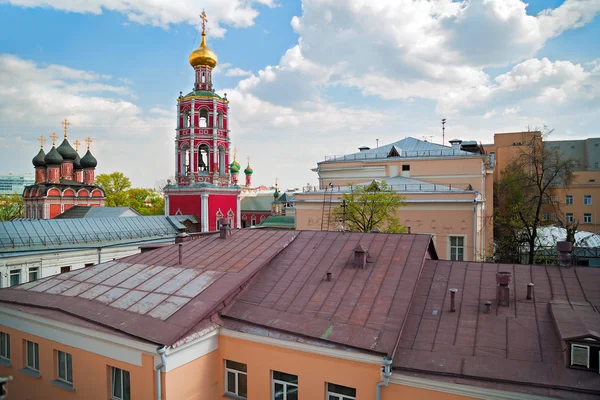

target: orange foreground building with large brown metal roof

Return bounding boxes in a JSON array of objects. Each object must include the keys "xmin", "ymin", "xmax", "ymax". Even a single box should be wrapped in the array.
[{"xmin": 0, "ymin": 228, "xmax": 600, "ymax": 400}]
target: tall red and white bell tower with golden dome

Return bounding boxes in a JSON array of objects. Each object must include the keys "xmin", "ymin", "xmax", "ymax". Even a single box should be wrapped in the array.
[{"xmin": 164, "ymin": 11, "xmax": 240, "ymax": 232}]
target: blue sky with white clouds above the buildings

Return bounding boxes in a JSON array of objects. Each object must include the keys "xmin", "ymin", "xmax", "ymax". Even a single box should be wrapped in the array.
[{"xmin": 0, "ymin": 0, "xmax": 600, "ymax": 188}]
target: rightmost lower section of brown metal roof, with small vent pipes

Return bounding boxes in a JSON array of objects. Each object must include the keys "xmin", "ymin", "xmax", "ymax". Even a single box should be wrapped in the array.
[{"xmin": 393, "ymin": 260, "xmax": 600, "ymax": 398}]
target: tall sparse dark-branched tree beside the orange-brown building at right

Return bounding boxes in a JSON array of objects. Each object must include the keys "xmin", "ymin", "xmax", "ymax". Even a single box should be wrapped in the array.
[{"xmin": 494, "ymin": 127, "xmax": 576, "ymax": 264}]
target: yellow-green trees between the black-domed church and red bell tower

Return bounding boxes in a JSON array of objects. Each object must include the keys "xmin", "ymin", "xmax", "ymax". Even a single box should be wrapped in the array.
[{"xmin": 96, "ymin": 172, "xmax": 165, "ymax": 215}]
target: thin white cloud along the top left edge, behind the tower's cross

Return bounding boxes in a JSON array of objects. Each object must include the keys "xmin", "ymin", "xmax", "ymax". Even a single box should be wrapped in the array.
[{"xmin": 6, "ymin": 0, "xmax": 276, "ymax": 37}]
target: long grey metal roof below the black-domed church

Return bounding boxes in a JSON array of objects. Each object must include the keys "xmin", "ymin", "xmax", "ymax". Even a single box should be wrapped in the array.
[{"xmin": 0, "ymin": 215, "xmax": 196, "ymax": 253}]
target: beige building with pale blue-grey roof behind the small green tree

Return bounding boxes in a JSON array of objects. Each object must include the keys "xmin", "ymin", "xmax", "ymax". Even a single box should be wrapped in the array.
[{"xmin": 295, "ymin": 137, "xmax": 493, "ymax": 261}]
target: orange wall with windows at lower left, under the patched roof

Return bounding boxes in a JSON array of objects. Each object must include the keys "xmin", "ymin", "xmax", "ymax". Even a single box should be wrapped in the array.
[{"xmin": 0, "ymin": 325, "xmax": 155, "ymax": 400}]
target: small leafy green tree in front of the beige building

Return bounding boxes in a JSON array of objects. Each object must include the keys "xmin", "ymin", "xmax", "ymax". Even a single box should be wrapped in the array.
[{"xmin": 332, "ymin": 181, "xmax": 406, "ymax": 233}]
